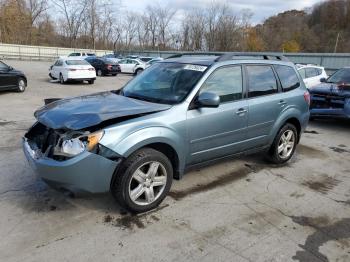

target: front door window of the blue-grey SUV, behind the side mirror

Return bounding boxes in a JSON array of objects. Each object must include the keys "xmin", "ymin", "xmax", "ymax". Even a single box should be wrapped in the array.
[{"xmin": 200, "ymin": 66, "xmax": 243, "ymax": 102}]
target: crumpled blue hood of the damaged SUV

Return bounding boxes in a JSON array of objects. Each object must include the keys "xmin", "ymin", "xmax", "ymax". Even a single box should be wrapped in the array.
[{"xmin": 34, "ymin": 92, "xmax": 171, "ymax": 130}]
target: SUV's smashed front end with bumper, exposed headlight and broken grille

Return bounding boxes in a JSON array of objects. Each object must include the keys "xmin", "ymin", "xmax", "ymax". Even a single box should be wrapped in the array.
[{"xmin": 23, "ymin": 122, "xmax": 122, "ymax": 193}]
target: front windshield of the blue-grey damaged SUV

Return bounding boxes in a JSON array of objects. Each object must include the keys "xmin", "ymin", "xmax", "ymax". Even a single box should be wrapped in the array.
[{"xmin": 121, "ymin": 63, "xmax": 207, "ymax": 104}]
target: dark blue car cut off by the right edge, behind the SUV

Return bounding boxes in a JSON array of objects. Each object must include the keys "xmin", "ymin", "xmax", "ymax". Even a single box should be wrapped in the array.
[{"xmin": 310, "ymin": 67, "xmax": 350, "ymax": 119}]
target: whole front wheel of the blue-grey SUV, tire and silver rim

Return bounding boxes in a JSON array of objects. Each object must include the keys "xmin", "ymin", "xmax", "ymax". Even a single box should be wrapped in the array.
[{"xmin": 111, "ymin": 148, "xmax": 173, "ymax": 213}]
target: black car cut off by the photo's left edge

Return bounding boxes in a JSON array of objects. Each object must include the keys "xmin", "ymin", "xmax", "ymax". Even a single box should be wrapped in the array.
[{"xmin": 0, "ymin": 61, "xmax": 27, "ymax": 92}]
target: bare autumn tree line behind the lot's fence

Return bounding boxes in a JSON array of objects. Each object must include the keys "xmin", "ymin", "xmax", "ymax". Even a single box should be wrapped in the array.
[{"xmin": 0, "ymin": 0, "xmax": 350, "ymax": 52}]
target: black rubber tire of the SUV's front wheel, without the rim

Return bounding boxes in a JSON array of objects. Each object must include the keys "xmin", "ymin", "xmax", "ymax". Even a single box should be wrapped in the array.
[{"xmin": 112, "ymin": 148, "xmax": 173, "ymax": 213}]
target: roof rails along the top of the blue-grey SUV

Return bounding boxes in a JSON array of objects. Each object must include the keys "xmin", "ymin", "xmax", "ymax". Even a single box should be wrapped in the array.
[{"xmin": 166, "ymin": 52, "xmax": 290, "ymax": 62}]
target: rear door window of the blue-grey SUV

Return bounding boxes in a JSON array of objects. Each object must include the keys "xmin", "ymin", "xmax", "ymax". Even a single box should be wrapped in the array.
[{"xmin": 246, "ymin": 65, "xmax": 278, "ymax": 97}]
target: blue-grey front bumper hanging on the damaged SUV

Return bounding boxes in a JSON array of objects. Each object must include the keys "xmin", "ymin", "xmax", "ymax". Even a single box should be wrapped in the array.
[{"xmin": 22, "ymin": 138, "xmax": 121, "ymax": 193}]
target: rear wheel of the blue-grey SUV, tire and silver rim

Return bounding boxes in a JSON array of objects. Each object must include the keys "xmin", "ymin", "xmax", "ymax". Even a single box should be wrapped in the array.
[{"xmin": 268, "ymin": 123, "xmax": 298, "ymax": 164}]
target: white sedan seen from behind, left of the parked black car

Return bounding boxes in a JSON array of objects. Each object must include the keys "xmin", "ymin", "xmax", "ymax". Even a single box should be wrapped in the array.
[{"xmin": 49, "ymin": 58, "xmax": 96, "ymax": 84}]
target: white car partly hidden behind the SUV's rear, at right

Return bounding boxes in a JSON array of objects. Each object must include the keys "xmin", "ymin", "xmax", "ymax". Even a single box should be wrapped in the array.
[{"xmin": 296, "ymin": 64, "xmax": 328, "ymax": 88}]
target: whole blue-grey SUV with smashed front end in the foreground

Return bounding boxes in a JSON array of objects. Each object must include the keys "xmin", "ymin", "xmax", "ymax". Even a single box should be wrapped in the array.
[{"xmin": 23, "ymin": 53, "xmax": 310, "ymax": 212}]
